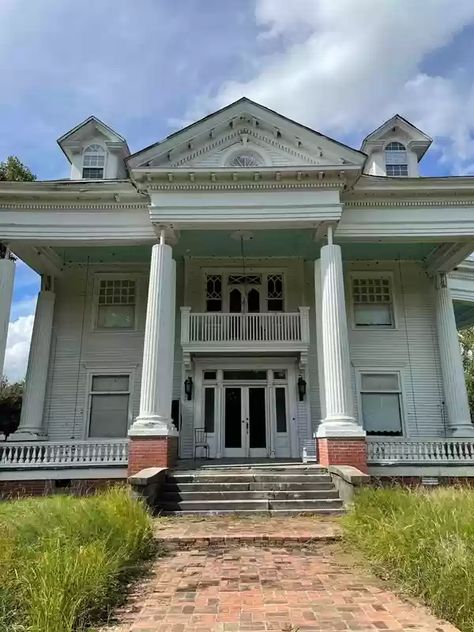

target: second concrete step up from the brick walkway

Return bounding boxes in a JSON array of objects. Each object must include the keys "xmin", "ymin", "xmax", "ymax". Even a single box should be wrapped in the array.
[{"xmin": 162, "ymin": 489, "xmax": 339, "ymax": 502}]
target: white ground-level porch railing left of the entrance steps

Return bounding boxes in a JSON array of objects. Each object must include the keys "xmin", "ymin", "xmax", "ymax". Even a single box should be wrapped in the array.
[{"xmin": 0, "ymin": 439, "xmax": 128, "ymax": 469}]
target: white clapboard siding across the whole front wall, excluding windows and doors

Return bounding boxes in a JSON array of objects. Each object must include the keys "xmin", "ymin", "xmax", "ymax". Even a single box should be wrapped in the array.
[{"xmin": 44, "ymin": 258, "xmax": 444, "ymax": 450}]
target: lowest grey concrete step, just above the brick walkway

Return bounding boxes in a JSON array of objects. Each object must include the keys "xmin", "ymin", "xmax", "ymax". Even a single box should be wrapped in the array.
[{"xmin": 161, "ymin": 498, "xmax": 342, "ymax": 513}]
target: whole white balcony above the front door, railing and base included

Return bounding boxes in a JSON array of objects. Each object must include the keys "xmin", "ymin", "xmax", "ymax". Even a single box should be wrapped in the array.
[{"xmin": 181, "ymin": 307, "xmax": 309, "ymax": 360}]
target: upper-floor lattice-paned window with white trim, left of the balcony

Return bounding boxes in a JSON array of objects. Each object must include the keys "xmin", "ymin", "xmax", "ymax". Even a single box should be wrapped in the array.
[{"xmin": 96, "ymin": 278, "xmax": 137, "ymax": 329}]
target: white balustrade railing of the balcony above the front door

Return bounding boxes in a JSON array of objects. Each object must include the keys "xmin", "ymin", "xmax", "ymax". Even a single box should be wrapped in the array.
[{"xmin": 181, "ymin": 307, "xmax": 309, "ymax": 344}]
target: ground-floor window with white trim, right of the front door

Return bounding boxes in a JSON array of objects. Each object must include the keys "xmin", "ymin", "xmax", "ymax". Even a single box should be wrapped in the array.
[{"xmin": 360, "ymin": 371, "xmax": 403, "ymax": 437}]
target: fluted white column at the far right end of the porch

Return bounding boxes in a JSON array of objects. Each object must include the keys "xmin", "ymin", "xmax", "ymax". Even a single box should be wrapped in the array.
[{"xmin": 435, "ymin": 274, "xmax": 474, "ymax": 437}]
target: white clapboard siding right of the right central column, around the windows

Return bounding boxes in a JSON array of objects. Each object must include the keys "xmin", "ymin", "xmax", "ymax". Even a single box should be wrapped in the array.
[{"xmin": 346, "ymin": 262, "xmax": 444, "ymax": 436}]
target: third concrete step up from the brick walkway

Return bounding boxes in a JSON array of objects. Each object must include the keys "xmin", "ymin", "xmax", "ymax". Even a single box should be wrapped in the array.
[{"xmin": 163, "ymin": 479, "xmax": 334, "ymax": 493}]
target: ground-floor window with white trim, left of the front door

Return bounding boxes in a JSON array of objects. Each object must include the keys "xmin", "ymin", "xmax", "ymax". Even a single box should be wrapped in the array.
[{"xmin": 89, "ymin": 374, "xmax": 130, "ymax": 439}]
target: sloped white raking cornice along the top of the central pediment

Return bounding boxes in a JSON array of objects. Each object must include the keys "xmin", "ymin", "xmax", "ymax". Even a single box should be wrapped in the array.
[{"xmin": 127, "ymin": 97, "xmax": 367, "ymax": 168}]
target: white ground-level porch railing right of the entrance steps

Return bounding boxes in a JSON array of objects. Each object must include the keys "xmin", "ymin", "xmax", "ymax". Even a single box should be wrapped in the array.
[{"xmin": 367, "ymin": 437, "xmax": 474, "ymax": 465}]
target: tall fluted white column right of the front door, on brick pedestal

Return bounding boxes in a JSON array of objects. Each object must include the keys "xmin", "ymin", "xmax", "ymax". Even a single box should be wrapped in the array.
[{"xmin": 315, "ymin": 228, "xmax": 365, "ymax": 438}]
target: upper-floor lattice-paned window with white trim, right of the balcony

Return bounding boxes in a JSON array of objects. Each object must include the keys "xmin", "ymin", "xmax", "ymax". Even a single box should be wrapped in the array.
[{"xmin": 352, "ymin": 275, "xmax": 395, "ymax": 329}]
